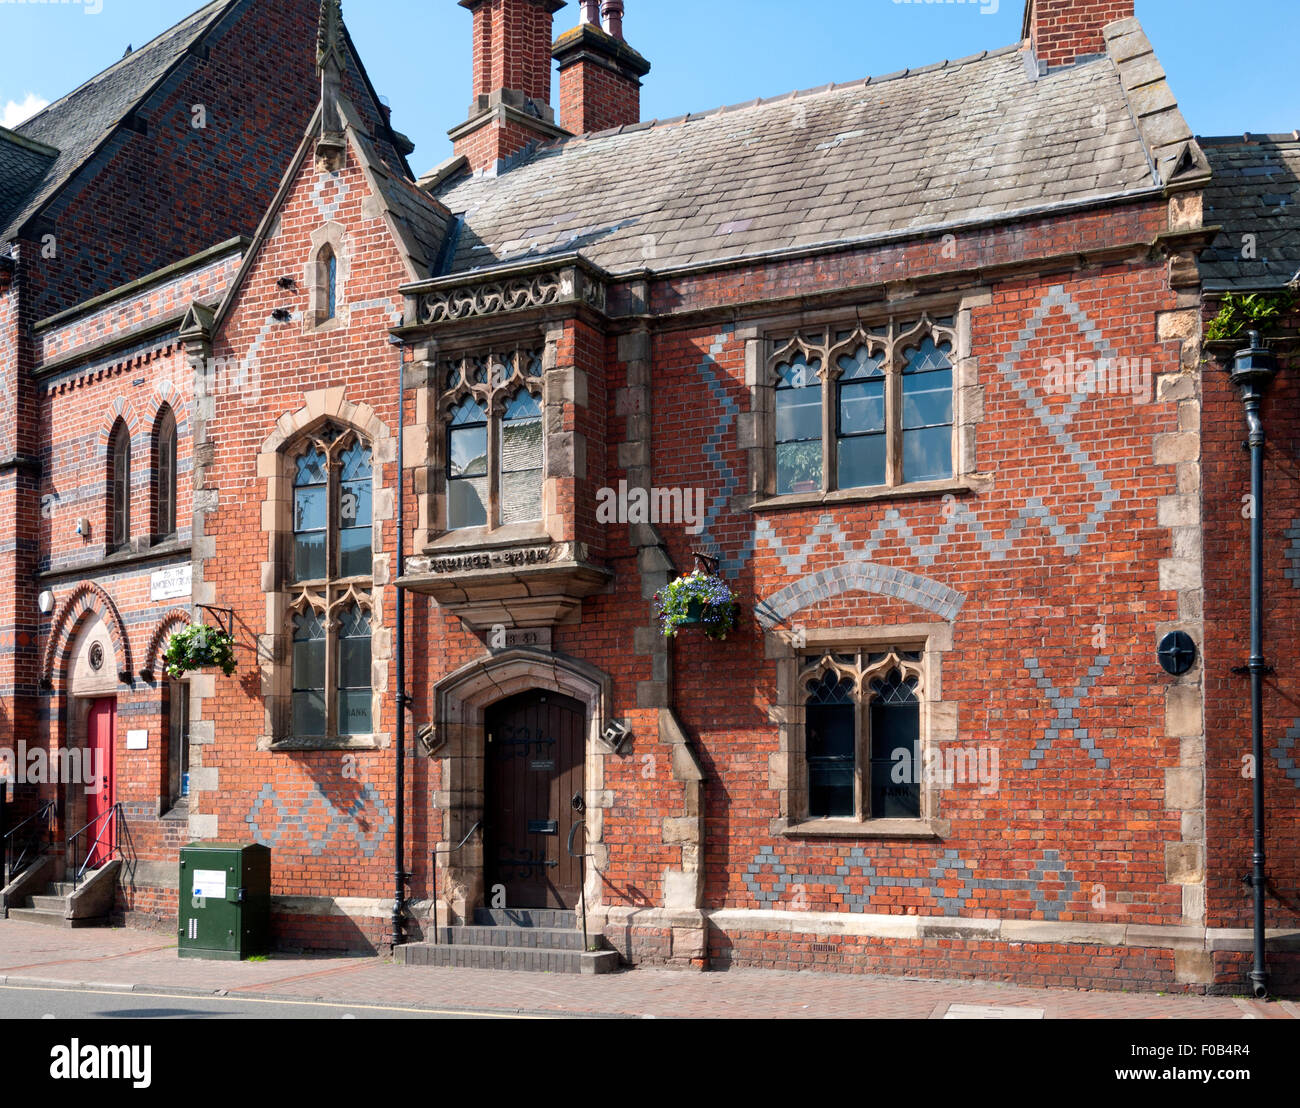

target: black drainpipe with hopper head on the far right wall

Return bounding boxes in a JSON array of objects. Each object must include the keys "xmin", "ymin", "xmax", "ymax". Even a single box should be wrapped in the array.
[{"xmin": 1230, "ymin": 330, "xmax": 1278, "ymax": 997}]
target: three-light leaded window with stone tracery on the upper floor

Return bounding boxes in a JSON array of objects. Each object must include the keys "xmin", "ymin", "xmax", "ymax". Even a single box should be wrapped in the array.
[{"xmin": 768, "ymin": 316, "xmax": 956, "ymax": 495}]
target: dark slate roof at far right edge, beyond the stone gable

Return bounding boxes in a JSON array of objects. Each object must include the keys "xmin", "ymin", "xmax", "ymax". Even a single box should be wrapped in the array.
[{"xmin": 1200, "ymin": 133, "xmax": 1300, "ymax": 290}]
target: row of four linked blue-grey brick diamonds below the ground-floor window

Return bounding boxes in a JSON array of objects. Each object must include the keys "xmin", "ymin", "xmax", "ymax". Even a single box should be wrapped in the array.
[{"xmin": 745, "ymin": 847, "xmax": 1080, "ymax": 919}]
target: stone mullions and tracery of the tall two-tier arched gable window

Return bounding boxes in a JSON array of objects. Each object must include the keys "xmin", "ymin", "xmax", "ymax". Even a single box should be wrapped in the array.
[{"xmin": 283, "ymin": 420, "xmax": 377, "ymax": 745}]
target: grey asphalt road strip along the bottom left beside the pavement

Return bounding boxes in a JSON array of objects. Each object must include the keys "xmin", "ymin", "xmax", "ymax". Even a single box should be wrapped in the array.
[{"xmin": 0, "ymin": 986, "xmax": 527, "ymax": 1020}]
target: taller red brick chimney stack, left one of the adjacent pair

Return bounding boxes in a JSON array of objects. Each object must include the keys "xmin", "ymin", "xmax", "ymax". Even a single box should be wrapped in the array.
[{"xmin": 450, "ymin": 0, "xmax": 566, "ymax": 173}]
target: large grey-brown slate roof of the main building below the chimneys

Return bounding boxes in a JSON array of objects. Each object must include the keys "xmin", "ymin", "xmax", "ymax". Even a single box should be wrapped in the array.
[{"xmin": 436, "ymin": 47, "xmax": 1162, "ymax": 273}]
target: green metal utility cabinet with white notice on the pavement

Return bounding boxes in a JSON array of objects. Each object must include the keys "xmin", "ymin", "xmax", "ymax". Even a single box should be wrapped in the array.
[{"xmin": 177, "ymin": 843, "xmax": 270, "ymax": 961}]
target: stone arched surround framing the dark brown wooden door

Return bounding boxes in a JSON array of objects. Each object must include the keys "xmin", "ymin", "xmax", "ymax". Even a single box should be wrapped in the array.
[{"xmin": 421, "ymin": 649, "xmax": 614, "ymax": 919}]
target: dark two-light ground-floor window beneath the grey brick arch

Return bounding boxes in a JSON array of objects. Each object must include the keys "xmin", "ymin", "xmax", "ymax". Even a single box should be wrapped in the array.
[{"xmin": 800, "ymin": 648, "xmax": 922, "ymax": 819}]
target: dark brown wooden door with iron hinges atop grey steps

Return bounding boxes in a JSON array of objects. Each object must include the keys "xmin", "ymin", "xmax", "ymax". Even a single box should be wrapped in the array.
[{"xmin": 484, "ymin": 691, "xmax": 586, "ymax": 908}]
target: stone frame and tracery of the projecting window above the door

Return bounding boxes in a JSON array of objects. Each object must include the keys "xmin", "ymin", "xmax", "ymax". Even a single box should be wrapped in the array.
[{"xmin": 436, "ymin": 343, "xmax": 540, "ymax": 540}]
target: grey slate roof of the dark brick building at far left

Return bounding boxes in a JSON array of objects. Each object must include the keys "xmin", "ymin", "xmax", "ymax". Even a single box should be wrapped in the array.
[{"xmin": 0, "ymin": 0, "xmax": 238, "ymax": 243}]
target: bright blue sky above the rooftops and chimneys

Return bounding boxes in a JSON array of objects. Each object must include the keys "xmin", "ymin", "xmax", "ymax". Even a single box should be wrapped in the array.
[{"xmin": 0, "ymin": 0, "xmax": 1300, "ymax": 173}]
